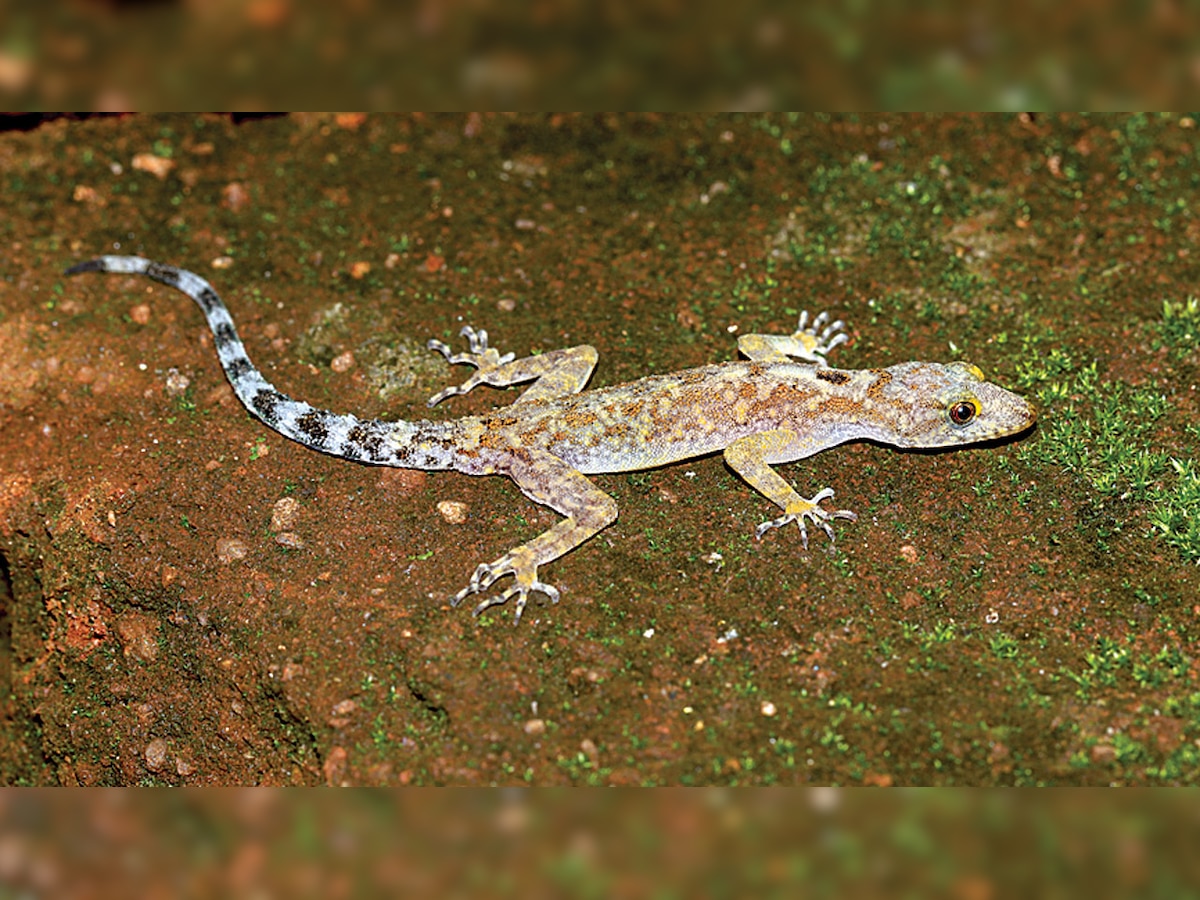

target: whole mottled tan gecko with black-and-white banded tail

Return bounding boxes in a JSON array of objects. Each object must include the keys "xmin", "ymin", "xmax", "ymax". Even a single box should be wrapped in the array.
[{"xmin": 65, "ymin": 256, "xmax": 1037, "ymax": 624}]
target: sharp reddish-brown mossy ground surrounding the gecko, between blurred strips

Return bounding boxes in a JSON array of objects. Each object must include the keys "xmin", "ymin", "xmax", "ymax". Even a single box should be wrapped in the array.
[{"xmin": 0, "ymin": 114, "xmax": 1200, "ymax": 785}]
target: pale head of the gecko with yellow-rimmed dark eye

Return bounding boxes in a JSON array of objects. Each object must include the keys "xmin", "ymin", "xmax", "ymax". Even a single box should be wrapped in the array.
[{"xmin": 886, "ymin": 362, "xmax": 1037, "ymax": 448}]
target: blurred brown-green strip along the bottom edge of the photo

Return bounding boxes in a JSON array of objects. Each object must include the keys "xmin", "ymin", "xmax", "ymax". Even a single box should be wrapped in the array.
[{"xmin": 0, "ymin": 788, "xmax": 1200, "ymax": 900}]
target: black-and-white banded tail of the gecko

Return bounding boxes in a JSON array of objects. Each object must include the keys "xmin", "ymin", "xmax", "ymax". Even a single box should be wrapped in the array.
[{"xmin": 64, "ymin": 256, "xmax": 448, "ymax": 469}]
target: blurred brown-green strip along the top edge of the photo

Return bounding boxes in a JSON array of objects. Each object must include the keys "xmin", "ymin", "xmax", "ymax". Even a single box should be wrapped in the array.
[{"xmin": 0, "ymin": 0, "xmax": 1200, "ymax": 110}]
